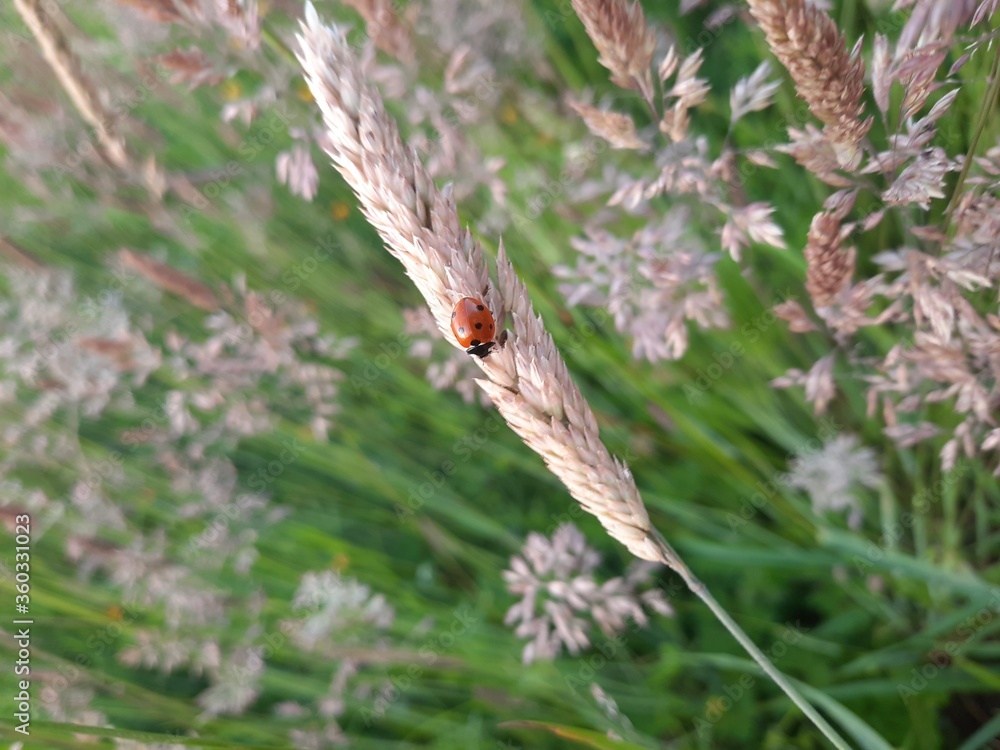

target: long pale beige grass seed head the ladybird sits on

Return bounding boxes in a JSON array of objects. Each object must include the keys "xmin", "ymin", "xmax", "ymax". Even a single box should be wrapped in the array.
[{"xmin": 298, "ymin": 4, "xmax": 662, "ymax": 561}]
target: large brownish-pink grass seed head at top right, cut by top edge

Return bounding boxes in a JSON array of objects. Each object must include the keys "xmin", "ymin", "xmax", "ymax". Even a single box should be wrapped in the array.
[{"xmin": 748, "ymin": 0, "xmax": 872, "ymax": 169}]
